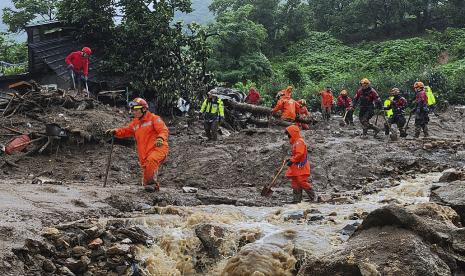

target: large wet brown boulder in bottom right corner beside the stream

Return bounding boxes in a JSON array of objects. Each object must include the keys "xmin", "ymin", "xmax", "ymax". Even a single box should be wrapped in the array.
[{"xmin": 298, "ymin": 203, "xmax": 465, "ymax": 275}]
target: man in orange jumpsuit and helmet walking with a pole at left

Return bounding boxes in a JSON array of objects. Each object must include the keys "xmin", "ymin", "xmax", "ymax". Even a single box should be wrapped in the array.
[{"xmin": 107, "ymin": 98, "xmax": 169, "ymax": 192}]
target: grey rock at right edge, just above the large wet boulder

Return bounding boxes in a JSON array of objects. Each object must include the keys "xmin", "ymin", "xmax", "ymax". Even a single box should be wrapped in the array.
[{"xmin": 430, "ymin": 181, "xmax": 465, "ymax": 225}]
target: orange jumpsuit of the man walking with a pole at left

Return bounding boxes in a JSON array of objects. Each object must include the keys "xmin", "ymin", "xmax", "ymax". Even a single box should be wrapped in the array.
[{"xmin": 115, "ymin": 111, "xmax": 169, "ymax": 185}]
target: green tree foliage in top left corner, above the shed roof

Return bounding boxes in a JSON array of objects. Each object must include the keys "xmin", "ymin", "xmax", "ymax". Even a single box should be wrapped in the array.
[{"xmin": 2, "ymin": 0, "xmax": 61, "ymax": 33}]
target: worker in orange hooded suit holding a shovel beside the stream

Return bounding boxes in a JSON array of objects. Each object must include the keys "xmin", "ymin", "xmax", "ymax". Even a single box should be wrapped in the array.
[{"xmin": 285, "ymin": 125, "xmax": 316, "ymax": 203}]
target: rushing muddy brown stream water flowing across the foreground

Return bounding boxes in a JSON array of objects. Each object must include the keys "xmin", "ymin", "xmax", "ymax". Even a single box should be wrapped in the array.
[{"xmin": 121, "ymin": 173, "xmax": 440, "ymax": 275}]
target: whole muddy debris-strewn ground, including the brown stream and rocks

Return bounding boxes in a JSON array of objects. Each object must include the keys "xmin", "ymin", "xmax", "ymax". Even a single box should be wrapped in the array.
[{"xmin": 0, "ymin": 89, "xmax": 465, "ymax": 276}]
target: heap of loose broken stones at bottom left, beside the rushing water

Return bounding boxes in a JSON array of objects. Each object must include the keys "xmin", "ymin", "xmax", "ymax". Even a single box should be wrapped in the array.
[{"xmin": 13, "ymin": 220, "xmax": 153, "ymax": 275}]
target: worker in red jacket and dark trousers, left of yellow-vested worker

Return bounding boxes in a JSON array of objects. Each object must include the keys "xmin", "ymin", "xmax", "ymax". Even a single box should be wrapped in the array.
[{"xmin": 354, "ymin": 78, "xmax": 382, "ymax": 137}]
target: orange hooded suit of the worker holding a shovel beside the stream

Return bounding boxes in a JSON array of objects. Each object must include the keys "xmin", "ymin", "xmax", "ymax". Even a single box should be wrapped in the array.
[{"xmin": 286, "ymin": 125, "xmax": 312, "ymax": 190}]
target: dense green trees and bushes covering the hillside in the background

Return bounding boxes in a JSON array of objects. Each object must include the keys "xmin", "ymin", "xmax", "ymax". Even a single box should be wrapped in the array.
[{"xmin": 3, "ymin": 0, "xmax": 465, "ymax": 109}]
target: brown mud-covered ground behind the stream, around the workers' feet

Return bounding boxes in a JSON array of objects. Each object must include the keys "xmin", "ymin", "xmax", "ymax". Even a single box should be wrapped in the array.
[{"xmin": 0, "ymin": 101, "xmax": 465, "ymax": 275}]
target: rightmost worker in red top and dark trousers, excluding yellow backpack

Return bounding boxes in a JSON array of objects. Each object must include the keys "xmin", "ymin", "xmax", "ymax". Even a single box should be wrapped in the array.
[{"xmin": 413, "ymin": 81, "xmax": 429, "ymax": 138}]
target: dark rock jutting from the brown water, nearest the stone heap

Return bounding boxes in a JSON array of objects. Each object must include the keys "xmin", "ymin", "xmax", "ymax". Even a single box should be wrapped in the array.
[{"xmin": 195, "ymin": 224, "xmax": 229, "ymax": 258}]
